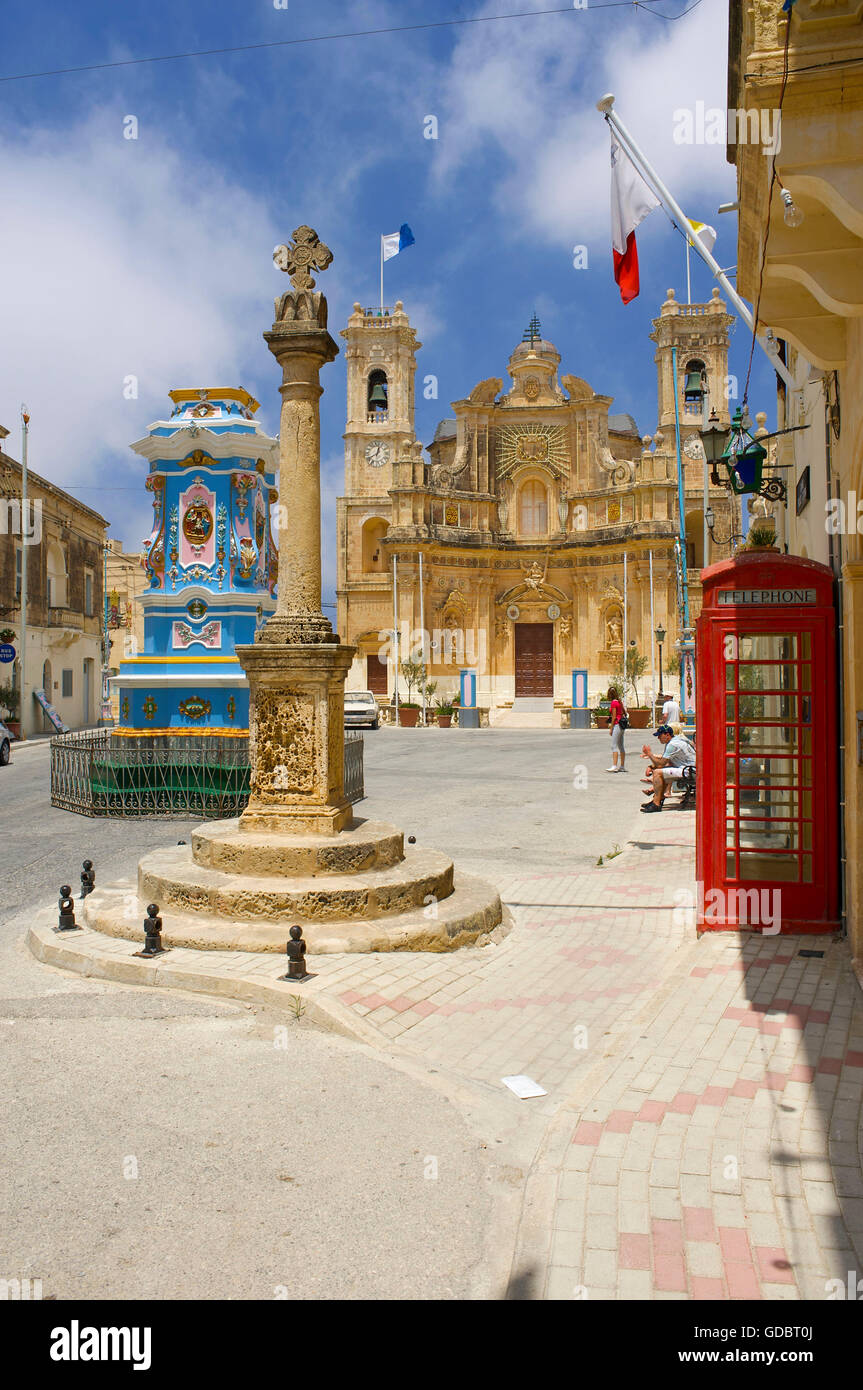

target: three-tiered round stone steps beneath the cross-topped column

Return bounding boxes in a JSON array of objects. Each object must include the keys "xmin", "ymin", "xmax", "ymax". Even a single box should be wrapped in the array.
[{"xmin": 85, "ymin": 820, "xmax": 510, "ymax": 954}]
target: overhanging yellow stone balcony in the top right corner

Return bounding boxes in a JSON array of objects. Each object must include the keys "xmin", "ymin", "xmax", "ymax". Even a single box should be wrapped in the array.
[{"xmin": 728, "ymin": 0, "xmax": 863, "ymax": 370}]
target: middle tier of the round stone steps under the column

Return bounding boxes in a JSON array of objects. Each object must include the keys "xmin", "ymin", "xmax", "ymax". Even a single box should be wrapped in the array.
[{"xmin": 138, "ymin": 845, "xmax": 453, "ymax": 930}]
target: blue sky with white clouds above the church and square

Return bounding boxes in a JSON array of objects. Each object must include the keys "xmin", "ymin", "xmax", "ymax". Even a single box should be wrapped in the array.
[{"xmin": 0, "ymin": 0, "xmax": 775, "ymax": 602}]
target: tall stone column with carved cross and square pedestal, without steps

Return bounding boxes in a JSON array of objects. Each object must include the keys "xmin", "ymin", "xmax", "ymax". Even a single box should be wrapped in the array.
[{"xmin": 236, "ymin": 227, "xmax": 354, "ymax": 835}]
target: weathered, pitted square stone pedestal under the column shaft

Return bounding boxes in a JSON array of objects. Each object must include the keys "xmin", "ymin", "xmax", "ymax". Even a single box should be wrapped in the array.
[{"xmin": 236, "ymin": 635, "xmax": 354, "ymax": 835}]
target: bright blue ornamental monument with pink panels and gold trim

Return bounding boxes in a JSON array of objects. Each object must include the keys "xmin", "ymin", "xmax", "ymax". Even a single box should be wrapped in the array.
[{"xmin": 114, "ymin": 386, "xmax": 278, "ymax": 739}]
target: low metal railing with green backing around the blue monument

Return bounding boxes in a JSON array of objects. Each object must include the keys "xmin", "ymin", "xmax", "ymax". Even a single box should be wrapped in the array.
[{"xmin": 51, "ymin": 728, "xmax": 365, "ymax": 820}]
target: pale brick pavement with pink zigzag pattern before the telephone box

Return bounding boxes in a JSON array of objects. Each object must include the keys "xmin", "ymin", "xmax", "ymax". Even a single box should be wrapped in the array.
[{"xmin": 33, "ymin": 812, "xmax": 863, "ymax": 1300}]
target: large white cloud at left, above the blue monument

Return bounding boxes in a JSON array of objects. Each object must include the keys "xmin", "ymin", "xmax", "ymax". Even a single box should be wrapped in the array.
[{"xmin": 0, "ymin": 113, "xmax": 282, "ymax": 544}]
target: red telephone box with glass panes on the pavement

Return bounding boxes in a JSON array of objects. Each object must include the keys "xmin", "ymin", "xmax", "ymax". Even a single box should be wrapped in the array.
[{"xmin": 696, "ymin": 550, "xmax": 839, "ymax": 935}]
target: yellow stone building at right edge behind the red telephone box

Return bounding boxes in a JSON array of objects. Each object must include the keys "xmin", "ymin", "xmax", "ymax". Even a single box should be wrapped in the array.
[{"xmin": 728, "ymin": 0, "xmax": 863, "ymax": 980}]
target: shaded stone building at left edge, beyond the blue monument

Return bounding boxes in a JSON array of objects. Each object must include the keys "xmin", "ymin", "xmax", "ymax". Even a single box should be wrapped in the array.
[{"xmin": 0, "ymin": 430, "xmax": 108, "ymax": 737}]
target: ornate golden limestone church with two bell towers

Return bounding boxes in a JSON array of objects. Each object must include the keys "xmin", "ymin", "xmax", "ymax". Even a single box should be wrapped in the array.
[{"xmin": 338, "ymin": 291, "xmax": 739, "ymax": 724}]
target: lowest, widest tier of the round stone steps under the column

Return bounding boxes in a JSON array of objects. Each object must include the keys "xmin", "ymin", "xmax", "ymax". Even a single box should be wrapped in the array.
[{"xmin": 82, "ymin": 878, "xmax": 511, "ymax": 970}]
